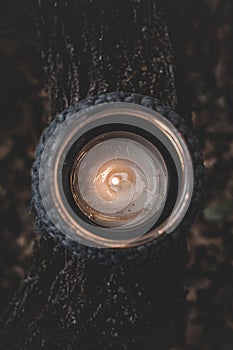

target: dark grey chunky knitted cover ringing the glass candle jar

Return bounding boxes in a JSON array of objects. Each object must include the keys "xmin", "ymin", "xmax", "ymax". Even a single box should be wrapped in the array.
[{"xmin": 32, "ymin": 92, "xmax": 203, "ymax": 264}]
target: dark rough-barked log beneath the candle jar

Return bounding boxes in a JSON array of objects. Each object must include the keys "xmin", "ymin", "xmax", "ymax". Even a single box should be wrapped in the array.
[{"xmin": 2, "ymin": 0, "xmax": 193, "ymax": 350}]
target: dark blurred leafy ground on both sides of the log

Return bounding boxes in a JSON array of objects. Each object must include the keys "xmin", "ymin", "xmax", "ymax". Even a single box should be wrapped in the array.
[{"xmin": 0, "ymin": 0, "xmax": 233, "ymax": 350}]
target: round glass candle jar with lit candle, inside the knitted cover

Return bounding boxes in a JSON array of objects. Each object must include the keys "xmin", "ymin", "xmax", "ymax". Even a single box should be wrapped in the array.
[{"xmin": 39, "ymin": 102, "xmax": 193, "ymax": 248}]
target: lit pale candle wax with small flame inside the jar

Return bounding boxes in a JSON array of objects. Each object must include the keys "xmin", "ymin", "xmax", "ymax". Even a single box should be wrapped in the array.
[{"xmin": 70, "ymin": 131, "xmax": 168, "ymax": 228}]
